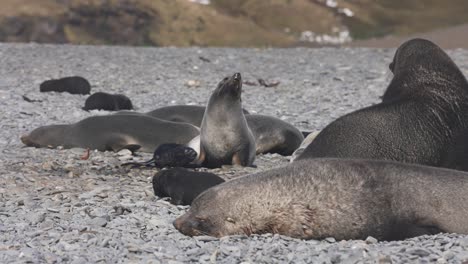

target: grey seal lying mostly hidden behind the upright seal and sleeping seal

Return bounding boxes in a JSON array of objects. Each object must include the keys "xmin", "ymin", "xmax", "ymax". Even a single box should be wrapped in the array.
[{"xmin": 145, "ymin": 105, "xmax": 249, "ymax": 127}]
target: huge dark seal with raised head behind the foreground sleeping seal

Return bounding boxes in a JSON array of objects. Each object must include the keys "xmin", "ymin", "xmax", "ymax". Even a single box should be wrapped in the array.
[{"xmin": 297, "ymin": 39, "xmax": 468, "ymax": 171}]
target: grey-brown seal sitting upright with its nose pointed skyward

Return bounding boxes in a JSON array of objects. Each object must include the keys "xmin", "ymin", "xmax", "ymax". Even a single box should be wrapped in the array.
[{"xmin": 200, "ymin": 73, "xmax": 255, "ymax": 167}]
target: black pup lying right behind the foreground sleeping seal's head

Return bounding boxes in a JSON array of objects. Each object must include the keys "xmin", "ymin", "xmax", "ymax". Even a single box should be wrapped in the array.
[{"xmin": 153, "ymin": 168, "xmax": 224, "ymax": 205}]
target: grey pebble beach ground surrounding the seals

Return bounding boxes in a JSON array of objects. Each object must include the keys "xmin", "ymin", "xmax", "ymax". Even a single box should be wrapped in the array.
[{"xmin": 0, "ymin": 44, "xmax": 468, "ymax": 263}]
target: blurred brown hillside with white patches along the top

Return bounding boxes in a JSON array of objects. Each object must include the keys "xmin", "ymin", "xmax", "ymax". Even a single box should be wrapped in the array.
[{"xmin": 0, "ymin": 0, "xmax": 468, "ymax": 47}]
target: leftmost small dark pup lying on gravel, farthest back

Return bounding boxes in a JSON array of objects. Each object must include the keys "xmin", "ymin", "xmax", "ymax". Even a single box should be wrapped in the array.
[{"xmin": 39, "ymin": 76, "xmax": 91, "ymax": 94}]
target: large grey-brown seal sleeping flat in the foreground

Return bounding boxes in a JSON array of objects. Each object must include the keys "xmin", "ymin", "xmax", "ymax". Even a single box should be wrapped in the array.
[{"xmin": 174, "ymin": 158, "xmax": 468, "ymax": 240}]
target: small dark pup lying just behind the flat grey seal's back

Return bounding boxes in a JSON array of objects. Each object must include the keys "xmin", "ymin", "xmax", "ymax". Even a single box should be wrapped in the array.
[{"xmin": 83, "ymin": 92, "xmax": 133, "ymax": 111}]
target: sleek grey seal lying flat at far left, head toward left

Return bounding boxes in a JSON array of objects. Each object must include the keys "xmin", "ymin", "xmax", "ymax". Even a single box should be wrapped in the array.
[{"xmin": 21, "ymin": 115, "xmax": 199, "ymax": 152}]
